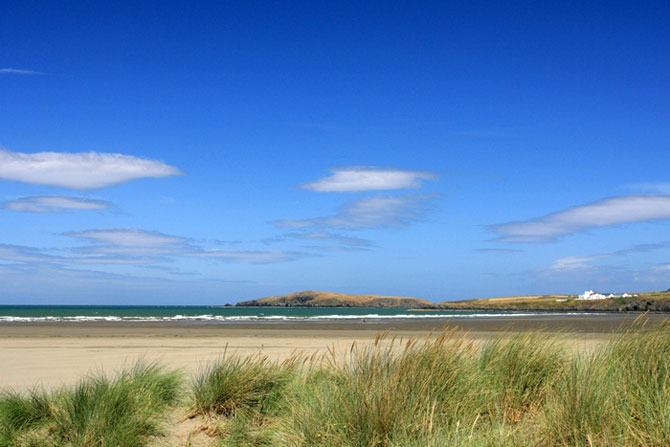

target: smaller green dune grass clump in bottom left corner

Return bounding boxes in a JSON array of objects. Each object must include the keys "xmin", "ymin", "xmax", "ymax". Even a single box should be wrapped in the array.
[{"xmin": 0, "ymin": 363, "xmax": 181, "ymax": 447}]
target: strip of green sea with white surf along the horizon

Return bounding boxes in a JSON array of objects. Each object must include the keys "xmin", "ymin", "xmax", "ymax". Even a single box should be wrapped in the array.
[{"xmin": 0, "ymin": 305, "xmax": 582, "ymax": 325}]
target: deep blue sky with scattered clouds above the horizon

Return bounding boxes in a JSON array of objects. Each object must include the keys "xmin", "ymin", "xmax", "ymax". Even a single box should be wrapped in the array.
[{"xmin": 0, "ymin": 0, "xmax": 670, "ymax": 304}]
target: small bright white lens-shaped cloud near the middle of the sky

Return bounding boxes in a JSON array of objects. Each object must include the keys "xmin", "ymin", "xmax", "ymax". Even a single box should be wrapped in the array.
[{"xmin": 302, "ymin": 166, "xmax": 437, "ymax": 192}]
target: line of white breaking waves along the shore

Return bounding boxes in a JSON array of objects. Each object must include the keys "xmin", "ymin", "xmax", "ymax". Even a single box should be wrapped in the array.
[{"xmin": 0, "ymin": 312, "xmax": 594, "ymax": 323}]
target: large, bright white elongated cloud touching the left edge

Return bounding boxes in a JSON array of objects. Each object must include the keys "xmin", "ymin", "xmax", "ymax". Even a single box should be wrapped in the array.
[{"xmin": 0, "ymin": 149, "xmax": 181, "ymax": 189}]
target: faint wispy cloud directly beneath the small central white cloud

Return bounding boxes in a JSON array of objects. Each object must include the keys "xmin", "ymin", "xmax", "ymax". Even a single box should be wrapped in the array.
[{"xmin": 272, "ymin": 194, "xmax": 436, "ymax": 230}]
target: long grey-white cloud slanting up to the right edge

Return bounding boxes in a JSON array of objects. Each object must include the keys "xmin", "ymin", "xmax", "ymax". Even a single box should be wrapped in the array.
[{"xmin": 488, "ymin": 194, "xmax": 670, "ymax": 242}]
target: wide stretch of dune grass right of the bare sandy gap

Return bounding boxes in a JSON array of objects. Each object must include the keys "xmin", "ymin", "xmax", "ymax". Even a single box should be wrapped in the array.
[{"xmin": 193, "ymin": 323, "xmax": 670, "ymax": 447}]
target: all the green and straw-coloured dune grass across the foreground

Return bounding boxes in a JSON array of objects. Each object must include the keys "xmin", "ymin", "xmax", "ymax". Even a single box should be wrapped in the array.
[{"xmin": 0, "ymin": 323, "xmax": 670, "ymax": 447}]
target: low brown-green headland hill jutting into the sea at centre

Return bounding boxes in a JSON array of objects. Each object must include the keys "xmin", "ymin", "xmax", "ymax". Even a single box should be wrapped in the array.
[{"xmin": 237, "ymin": 291, "xmax": 436, "ymax": 309}]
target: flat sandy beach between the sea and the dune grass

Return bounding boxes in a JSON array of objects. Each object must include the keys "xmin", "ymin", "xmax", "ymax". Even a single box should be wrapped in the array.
[{"xmin": 0, "ymin": 314, "xmax": 669, "ymax": 389}]
